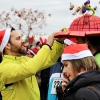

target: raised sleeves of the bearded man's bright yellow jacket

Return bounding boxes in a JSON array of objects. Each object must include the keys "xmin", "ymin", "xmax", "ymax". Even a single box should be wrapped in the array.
[{"xmin": 0, "ymin": 41, "xmax": 63, "ymax": 84}]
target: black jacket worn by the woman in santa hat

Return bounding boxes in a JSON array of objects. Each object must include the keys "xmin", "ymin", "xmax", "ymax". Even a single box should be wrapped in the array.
[{"xmin": 57, "ymin": 71, "xmax": 100, "ymax": 100}]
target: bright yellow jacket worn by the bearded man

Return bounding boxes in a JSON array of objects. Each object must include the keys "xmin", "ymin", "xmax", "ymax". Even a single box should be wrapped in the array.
[{"xmin": 0, "ymin": 41, "xmax": 63, "ymax": 100}]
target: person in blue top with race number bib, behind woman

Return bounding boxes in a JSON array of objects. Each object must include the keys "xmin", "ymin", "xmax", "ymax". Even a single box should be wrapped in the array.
[{"xmin": 47, "ymin": 38, "xmax": 76, "ymax": 100}]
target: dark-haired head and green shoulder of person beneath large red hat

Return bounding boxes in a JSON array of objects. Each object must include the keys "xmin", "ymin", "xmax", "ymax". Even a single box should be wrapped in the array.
[{"xmin": 76, "ymin": 36, "xmax": 100, "ymax": 66}]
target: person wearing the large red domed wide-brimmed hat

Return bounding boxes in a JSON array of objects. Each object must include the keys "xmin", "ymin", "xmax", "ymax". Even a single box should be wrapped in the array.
[{"xmin": 58, "ymin": 14, "xmax": 100, "ymax": 66}]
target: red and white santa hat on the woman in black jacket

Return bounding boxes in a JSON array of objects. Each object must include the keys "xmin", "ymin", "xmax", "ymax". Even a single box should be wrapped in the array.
[{"xmin": 62, "ymin": 44, "xmax": 93, "ymax": 60}]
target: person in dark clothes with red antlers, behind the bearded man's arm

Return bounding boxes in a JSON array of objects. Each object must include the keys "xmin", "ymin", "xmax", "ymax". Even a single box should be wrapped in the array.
[{"xmin": 36, "ymin": 37, "xmax": 50, "ymax": 100}]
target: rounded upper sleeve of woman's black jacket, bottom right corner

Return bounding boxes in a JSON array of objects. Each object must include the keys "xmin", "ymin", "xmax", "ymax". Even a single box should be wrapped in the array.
[{"xmin": 74, "ymin": 87, "xmax": 100, "ymax": 100}]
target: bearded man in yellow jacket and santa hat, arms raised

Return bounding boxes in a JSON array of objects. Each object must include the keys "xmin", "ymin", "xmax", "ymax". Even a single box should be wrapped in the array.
[{"xmin": 0, "ymin": 28, "xmax": 64, "ymax": 100}]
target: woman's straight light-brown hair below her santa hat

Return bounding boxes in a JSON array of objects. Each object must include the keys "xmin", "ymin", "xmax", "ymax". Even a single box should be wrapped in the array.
[{"xmin": 70, "ymin": 56, "xmax": 99, "ymax": 72}]
